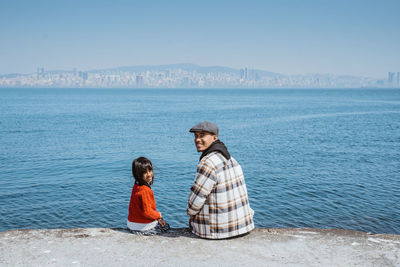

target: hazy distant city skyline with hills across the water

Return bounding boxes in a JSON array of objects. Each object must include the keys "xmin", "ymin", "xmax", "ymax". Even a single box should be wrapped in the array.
[{"xmin": 0, "ymin": 64, "xmax": 400, "ymax": 88}]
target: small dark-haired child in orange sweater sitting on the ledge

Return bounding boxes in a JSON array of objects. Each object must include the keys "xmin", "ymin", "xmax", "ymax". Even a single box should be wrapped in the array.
[{"xmin": 127, "ymin": 157, "xmax": 169, "ymax": 235}]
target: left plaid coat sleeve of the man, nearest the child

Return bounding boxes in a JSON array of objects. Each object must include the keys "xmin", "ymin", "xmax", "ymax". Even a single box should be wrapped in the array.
[{"xmin": 186, "ymin": 160, "xmax": 217, "ymax": 216}]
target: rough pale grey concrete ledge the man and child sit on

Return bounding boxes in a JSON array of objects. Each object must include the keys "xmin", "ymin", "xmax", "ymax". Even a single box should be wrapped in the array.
[{"xmin": 0, "ymin": 228, "xmax": 400, "ymax": 266}]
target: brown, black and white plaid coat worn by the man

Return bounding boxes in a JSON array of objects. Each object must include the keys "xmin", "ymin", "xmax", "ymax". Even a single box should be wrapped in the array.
[{"xmin": 187, "ymin": 152, "xmax": 254, "ymax": 239}]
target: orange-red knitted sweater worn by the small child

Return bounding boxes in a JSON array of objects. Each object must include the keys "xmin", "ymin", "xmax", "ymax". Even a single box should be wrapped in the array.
[{"xmin": 128, "ymin": 184, "xmax": 161, "ymax": 223}]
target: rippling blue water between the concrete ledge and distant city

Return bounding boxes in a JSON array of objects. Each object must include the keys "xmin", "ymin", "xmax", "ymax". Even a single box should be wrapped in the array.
[{"xmin": 0, "ymin": 89, "xmax": 400, "ymax": 234}]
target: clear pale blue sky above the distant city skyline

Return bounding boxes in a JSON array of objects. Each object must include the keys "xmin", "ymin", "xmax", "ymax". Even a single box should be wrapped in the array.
[{"xmin": 0, "ymin": 0, "xmax": 400, "ymax": 77}]
